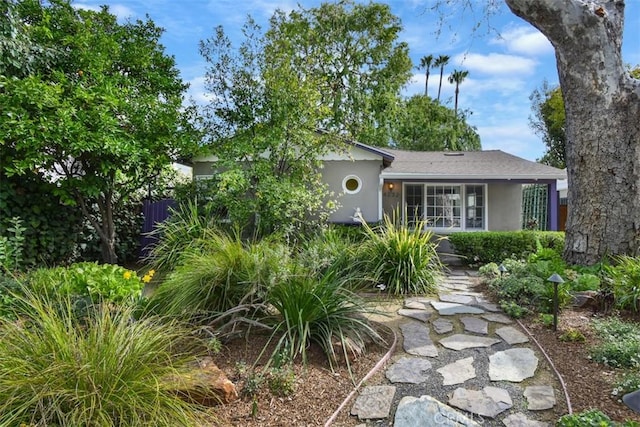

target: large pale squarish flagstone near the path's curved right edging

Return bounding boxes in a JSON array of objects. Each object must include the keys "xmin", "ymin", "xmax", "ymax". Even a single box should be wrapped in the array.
[{"xmin": 489, "ymin": 348, "xmax": 538, "ymax": 383}]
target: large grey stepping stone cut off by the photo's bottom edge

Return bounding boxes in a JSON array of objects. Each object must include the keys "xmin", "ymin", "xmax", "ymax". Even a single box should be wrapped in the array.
[{"xmin": 393, "ymin": 396, "xmax": 480, "ymax": 427}]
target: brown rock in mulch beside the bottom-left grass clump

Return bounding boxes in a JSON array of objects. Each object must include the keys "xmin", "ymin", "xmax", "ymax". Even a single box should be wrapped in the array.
[{"xmin": 167, "ymin": 357, "xmax": 238, "ymax": 406}]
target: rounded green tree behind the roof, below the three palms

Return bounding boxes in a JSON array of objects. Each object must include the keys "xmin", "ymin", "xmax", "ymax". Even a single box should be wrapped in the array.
[{"xmin": 393, "ymin": 95, "xmax": 481, "ymax": 151}]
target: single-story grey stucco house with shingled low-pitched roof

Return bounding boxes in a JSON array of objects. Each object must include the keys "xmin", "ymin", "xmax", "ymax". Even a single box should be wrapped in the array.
[{"xmin": 193, "ymin": 143, "xmax": 566, "ymax": 234}]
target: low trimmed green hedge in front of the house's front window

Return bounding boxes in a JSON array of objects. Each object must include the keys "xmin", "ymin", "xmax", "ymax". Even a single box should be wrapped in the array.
[{"xmin": 448, "ymin": 231, "xmax": 564, "ymax": 265}]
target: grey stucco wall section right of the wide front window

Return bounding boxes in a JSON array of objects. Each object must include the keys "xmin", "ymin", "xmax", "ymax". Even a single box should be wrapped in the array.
[{"xmin": 487, "ymin": 183, "xmax": 522, "ymax": 231}]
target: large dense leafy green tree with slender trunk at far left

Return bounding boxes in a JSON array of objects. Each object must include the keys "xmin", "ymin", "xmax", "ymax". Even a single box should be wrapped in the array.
[{"xmin": 0, "ymin": 0, "xmax": 197, "ymax": 263}]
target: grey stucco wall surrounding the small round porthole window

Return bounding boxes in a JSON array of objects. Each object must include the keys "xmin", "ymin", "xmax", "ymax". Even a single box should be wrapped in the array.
[{"xmin": 322, "ymin": 160, "xmax": 382, "ymax": 223}]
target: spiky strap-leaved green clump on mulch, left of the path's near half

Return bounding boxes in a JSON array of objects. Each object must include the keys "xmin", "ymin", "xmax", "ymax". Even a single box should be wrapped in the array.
[{"xmin": 268, "ymin": 272, "xmax": 380, "ymax": 366}]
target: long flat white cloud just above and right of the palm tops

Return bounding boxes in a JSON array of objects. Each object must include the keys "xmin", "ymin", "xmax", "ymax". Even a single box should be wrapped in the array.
[{"xmin": 454, "ymin": 53, "xmax": 538, "ymax": 75}]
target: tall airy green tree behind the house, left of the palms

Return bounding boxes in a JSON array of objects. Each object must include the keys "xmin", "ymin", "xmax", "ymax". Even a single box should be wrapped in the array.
[{"xmin": 269, "ymin": 0, "xmax": 413, "ymax": 146}]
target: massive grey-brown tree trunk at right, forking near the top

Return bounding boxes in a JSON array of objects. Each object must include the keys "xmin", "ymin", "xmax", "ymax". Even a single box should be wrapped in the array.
[{"xmin": 505, "ymin": 0, "xmax": 640, "ymax": 265}]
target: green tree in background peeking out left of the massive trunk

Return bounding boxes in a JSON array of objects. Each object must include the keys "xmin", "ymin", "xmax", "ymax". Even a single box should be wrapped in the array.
[{"xmin": 529, "ymin": 82, "xmax": 566, "ymax": 169}]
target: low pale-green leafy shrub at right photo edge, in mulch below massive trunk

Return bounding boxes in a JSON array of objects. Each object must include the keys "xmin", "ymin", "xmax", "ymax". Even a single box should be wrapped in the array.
[{"xmin": 590, "ymin": 317, "xmax": 640, "ymax": 368}]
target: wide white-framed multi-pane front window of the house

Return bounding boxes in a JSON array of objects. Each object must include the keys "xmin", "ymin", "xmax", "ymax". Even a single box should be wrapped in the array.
[{"xmin": 403, "ymin": 183, "xmax": 487, "ymax": 231}]
